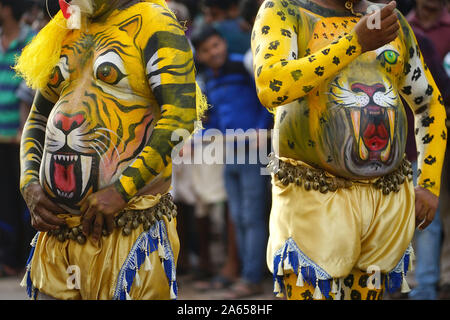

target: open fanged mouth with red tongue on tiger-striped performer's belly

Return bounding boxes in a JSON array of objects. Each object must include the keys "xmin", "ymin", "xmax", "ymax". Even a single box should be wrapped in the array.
[{"xmin": 45, "ymin": 152, "xmax": 96, "ymax": 206}]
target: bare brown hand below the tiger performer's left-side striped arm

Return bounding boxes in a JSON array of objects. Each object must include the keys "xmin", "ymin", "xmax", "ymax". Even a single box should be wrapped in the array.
[{"xmin": 22, "ymin": 183, "xmax": 66, "ymax": 232}]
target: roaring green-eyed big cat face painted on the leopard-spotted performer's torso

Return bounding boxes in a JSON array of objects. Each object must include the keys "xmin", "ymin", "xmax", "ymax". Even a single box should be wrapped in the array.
[{"xmin": 276, "ymin": 17, "xmax": 407, "ymax": 179}]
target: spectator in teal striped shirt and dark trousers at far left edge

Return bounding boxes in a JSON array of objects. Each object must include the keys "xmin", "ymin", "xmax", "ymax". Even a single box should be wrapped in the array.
[{"xmin": 0, "ymin": 0, "xmax": 34, "ymax": 277}]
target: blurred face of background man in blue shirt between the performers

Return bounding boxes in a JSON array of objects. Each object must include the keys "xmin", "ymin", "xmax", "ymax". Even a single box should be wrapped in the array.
[{"xmin": 196, "ymin": 35, "xmax": 227, "ymax": 70}]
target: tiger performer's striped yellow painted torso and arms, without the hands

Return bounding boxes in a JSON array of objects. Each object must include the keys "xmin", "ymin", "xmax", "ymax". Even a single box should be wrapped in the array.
[{"xmin": 21, "ymin": 2, "xmax": 197, "ymax": 214}]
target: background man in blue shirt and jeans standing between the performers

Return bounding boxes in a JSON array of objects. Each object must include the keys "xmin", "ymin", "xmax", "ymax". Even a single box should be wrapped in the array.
[{"xmin": 191, "ymin": 26, "xmax": 272, "ymax": 299}]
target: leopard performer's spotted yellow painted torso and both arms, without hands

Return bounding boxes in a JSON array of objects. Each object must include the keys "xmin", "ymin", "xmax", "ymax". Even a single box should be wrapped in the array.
[{"xmin": 252, "ymin": 0, "xmax": 447, "ymax": 196}]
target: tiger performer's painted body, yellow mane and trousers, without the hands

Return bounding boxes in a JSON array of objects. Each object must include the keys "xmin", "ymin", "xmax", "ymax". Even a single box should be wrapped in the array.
[{"xmin": 16, "ymin": 0, "xmax": 205, "ymax": 299}]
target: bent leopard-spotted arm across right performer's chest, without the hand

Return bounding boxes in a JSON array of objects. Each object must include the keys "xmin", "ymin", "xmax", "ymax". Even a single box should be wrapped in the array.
[{"xmin": 252, "ymin": 1, "xmax": 362, "ymax": 108}]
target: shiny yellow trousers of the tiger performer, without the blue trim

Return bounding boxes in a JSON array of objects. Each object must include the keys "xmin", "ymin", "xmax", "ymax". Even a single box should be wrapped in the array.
[{"xmin": 29, "ymin": 217, "xmax": 179, "ymax": 300}]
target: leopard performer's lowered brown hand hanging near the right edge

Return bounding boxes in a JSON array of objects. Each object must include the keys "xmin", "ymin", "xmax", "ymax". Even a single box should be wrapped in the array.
[{"xmin": 414, "ymin": 186, "xmax": 439, "ymax": 230}]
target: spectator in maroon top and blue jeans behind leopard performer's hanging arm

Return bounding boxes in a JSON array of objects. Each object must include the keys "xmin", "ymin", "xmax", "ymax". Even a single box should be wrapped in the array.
[{"xmin": 407, "ymin": 0, "xmax": 450, "ymax": 300}]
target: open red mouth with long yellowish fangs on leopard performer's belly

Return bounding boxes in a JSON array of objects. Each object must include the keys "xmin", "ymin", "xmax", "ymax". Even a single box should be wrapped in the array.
[{"xmin": 350, "ymin": 105, "xmax": 395, "ymax": 162}]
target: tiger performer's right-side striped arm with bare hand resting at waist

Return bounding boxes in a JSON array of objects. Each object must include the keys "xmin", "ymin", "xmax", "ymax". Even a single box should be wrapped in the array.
[{"xmin": 81, "ymin": 5, "xmax": 197, "ymax": 241}]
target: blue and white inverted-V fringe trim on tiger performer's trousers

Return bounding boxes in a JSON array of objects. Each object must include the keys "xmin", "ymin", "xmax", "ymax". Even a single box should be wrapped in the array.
[{"xmin": 113, "ymin": 221, "xmax": 178, "ymax": 300}]
